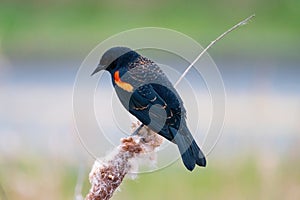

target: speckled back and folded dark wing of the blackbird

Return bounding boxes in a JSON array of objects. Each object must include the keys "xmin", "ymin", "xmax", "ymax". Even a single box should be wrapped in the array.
[{"xmin": 122, "ymin": 57, "xmax": 185, "ymax": 134}]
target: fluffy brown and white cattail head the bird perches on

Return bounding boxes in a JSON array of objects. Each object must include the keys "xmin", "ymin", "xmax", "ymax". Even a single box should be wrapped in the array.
[{"xmin": 85, "ymin": 126, "xmax": 163, "ymax": 200}]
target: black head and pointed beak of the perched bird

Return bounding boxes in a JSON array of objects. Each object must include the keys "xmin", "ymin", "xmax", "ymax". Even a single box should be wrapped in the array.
[{"xmin": 91, "ymin": 47, "xmax": 138, "ymax": 76}]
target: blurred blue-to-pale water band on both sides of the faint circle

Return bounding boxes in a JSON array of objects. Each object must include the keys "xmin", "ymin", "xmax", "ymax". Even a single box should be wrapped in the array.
[{"xmin": 0, "ymin": 60, "xmax": 300, "ymax": 159}]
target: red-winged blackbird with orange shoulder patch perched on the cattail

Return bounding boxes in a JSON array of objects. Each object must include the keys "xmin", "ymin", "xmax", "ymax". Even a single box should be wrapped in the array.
[{"xmin": 92, "ymin": 47, "xmax": 206, "ymax": 171}]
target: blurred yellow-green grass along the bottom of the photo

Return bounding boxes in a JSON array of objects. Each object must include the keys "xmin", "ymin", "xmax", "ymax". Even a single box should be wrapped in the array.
[{"xmin": 0, "ymin": 156, "xmax": 300, "ymax": 200}]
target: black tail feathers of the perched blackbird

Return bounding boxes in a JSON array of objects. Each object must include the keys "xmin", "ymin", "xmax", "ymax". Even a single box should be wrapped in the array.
[{"xmin": 170, "ymin": 127, "xmax": 206, "ymax": 171}]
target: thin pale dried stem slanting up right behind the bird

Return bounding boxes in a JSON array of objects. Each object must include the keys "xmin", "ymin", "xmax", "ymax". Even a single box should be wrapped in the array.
[{"xmin": 174, "ymin": 14, "xmax": 255, "ymax": 87}]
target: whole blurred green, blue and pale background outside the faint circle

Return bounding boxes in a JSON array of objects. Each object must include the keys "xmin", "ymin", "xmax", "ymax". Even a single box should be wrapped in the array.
[{"xmin": 0, "ymin": 0, "xmax": 300, "ymax": 200}]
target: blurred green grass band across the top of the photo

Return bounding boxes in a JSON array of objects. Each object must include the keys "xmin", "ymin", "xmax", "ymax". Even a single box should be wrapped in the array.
[{"xmin": 0, "ymin": 0, "xmax": 300, "ymax": 56}]
